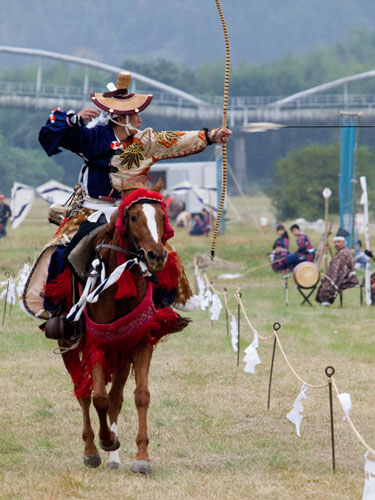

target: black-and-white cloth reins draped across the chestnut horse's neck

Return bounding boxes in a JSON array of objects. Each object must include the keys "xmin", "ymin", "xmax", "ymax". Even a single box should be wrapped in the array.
[{"xmin": 66, "ymin": 258, "xmax": 150, "ymax": 321}]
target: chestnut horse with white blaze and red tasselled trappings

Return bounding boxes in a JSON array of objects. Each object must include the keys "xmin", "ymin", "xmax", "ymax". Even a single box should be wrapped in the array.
[{"xmin": 59, "ymin": 183, "xmax": 188, "ymax": 474}]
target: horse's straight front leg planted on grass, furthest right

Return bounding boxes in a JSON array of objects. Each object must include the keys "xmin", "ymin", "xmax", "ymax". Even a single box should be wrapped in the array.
[{"xmin": 131, "ymin": 343, "xmax": 153, "ymax": 474}]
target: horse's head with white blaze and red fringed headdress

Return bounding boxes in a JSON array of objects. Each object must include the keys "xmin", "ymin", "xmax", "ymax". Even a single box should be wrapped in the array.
[{"xmin": 116, "ymin": 180, "xmax": 173, "ymax": 272}]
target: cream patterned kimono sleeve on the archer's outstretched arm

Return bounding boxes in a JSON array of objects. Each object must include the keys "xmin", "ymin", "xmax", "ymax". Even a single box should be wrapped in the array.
[{"xmin": 139, "ymin": 129, "xmax": 213, "ymax": 163}]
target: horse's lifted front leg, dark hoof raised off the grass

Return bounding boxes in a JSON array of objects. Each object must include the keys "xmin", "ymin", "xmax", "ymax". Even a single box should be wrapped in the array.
[{"xmin": 92, "ymin": 363, "xmax": 120, "ymax": 451}]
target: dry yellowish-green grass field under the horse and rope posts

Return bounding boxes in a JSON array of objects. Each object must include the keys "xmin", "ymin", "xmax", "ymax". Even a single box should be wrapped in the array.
[{"xmin": 0, "ymin": 197, "xmax": 375, "ymax": 500}]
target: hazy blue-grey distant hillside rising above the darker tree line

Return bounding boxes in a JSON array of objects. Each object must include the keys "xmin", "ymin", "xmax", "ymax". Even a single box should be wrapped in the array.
[{"xmin": 0, "ymin": 0, "xmax": 375, "ymax": 66}]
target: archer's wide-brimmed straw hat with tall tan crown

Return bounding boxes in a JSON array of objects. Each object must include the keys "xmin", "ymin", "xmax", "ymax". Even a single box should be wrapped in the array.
[{"xmin": 90, "ymin": 72, "xmax": 153, "ymax": 115}]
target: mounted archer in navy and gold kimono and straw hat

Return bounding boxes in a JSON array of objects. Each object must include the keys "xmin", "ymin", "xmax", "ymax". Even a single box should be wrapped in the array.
[{"xmin": 29, "ymin": 73, "xmax": 232, "ymax": 326}]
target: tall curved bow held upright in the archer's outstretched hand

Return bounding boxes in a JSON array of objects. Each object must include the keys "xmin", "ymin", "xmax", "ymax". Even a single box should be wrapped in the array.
[{"xmin": 211, "ymin": 0, "xmax": 230, "ymax": 260}]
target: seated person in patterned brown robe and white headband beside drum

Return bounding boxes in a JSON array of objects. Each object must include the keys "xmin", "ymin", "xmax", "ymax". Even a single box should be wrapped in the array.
[{"xmin": 316, "ymin": 227, "xmax": 358, "ymax": 306}]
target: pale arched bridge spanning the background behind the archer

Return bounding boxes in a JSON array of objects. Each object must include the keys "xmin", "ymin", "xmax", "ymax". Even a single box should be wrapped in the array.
[{"xmin": 0, "ymin": 46, "xmax": 375, "ymax": 128}]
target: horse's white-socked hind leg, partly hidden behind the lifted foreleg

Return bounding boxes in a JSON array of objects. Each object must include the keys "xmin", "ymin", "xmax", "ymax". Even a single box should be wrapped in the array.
[{"xmin": 107, "ymin": 360, "xmax": 130, "ymax": 470}]
